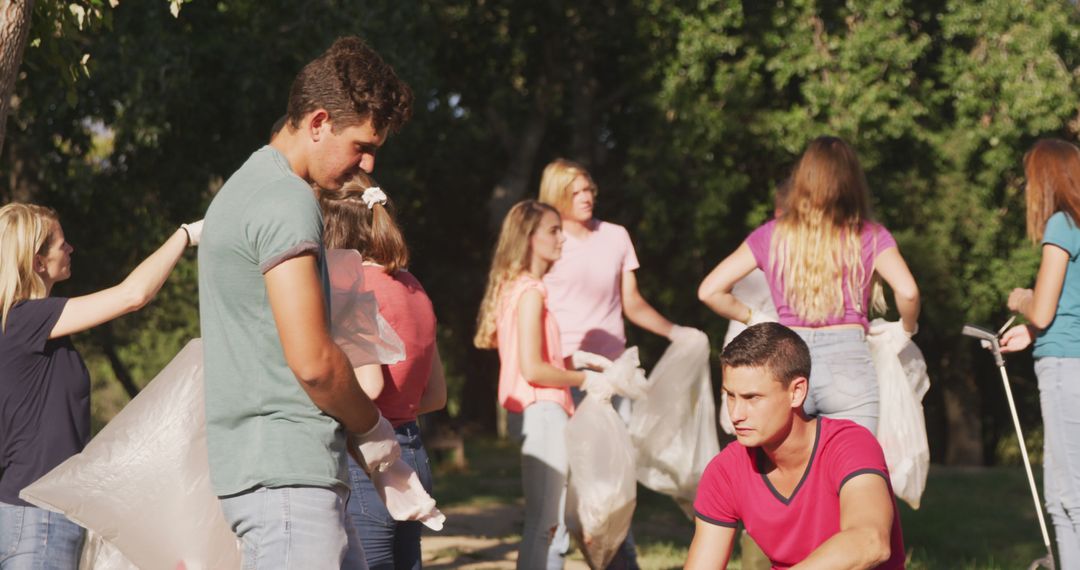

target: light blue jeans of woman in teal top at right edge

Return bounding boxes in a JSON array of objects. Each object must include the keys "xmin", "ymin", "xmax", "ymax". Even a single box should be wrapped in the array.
[{"xmin": 1035, "ymin": 356, "xmax": 1080, "ymax": 568}]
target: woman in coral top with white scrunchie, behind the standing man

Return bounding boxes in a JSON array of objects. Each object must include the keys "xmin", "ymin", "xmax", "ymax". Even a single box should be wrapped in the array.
[{"xmin": 319, "ymin": 173, "xmax": 446, "ymax": 570}]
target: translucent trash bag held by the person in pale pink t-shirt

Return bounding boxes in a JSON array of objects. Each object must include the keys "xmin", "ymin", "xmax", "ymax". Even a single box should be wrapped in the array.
[{"xmin": 630, "ymin": 331, "xmax": 720, "ymax": 516}]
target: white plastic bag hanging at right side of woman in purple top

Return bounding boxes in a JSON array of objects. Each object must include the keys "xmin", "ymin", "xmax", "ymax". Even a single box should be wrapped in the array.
[{"xmin": 866, "ymin": 318, "xmax": 930, "ymax": 508}]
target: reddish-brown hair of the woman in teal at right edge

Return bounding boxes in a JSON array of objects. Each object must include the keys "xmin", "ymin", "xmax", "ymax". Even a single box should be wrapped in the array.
[{"xmin": 1024, "ymin": 138, "xmax": 1080, "ymax": 243}]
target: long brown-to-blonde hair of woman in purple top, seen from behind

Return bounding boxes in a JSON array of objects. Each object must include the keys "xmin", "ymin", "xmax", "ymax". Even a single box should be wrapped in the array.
[{"xmin": 770, "ymin": 136, "xmax": 885, "ymax": 324}]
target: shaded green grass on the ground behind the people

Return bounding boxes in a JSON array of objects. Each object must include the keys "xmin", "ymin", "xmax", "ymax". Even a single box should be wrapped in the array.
[{"xmin": 435, "ymin": 439, "xmax": 1044, "ymax": 570}]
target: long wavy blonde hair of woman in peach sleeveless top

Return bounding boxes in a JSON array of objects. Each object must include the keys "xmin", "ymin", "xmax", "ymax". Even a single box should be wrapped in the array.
[{"xmin": 473, "ymin": 200, "xmax": 558, "ymax": 349}]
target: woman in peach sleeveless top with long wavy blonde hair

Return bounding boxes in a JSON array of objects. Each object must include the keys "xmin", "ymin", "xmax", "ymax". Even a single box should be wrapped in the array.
[{"xmin": 473, "ymin": 200, "xmax": 611, "ymax": 570}]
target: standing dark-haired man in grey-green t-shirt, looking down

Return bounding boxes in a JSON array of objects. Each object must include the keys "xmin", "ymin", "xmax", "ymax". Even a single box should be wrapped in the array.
[{"xmin": 199, "ymin": 38, "xmax": 413, "ymax": 569}]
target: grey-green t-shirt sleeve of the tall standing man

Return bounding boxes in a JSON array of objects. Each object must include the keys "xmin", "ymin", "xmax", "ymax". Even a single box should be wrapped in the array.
[{"xmin": 247, "ymin": 180, "xmax": 323, "ymax": 273}]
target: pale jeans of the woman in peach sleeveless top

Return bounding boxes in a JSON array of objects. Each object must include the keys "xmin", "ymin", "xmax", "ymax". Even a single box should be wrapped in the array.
[{"xmin": 517, "ymin": 402, "xmax": 569, "ymax": 570}]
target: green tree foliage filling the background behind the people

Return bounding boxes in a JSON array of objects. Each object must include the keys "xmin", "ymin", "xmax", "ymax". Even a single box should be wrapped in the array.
[{"xmin": 6, "ymin": 0, "xmax": 1080, "ymax": 458}]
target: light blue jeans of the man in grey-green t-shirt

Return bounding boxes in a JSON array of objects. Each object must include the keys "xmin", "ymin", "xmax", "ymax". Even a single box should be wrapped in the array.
[{"xmin": 218, "ymin": 487, "xmax": 367, "ymax": 570}]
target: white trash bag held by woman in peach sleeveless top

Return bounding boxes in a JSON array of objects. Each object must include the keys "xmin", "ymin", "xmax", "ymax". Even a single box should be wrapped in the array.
[{"xmin": 566, "ymin": 394, "xmax": 637, "ymax": 569}]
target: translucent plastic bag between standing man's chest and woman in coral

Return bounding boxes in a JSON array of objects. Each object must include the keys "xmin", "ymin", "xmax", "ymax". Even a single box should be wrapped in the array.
[{"xmin": 326, "ymin": 249, "xmax": 405, "ymax": 368}]
